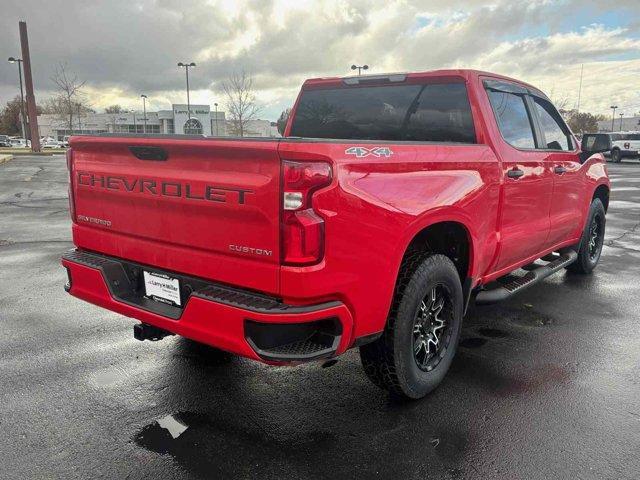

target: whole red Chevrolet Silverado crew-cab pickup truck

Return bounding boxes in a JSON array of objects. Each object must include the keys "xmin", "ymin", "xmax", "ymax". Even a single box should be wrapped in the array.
[{"xmin": 62, "ymin": 70, "xmax": 611, "ymax": 398}]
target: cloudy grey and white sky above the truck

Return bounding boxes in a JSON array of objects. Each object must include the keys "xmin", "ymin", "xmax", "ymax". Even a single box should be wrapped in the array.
[{"xmin": 0, "ymin": 0, "xmax": 640, "ymax": 119}]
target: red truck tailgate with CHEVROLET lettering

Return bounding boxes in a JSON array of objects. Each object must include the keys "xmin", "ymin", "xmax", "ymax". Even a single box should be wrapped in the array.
[{"xmin": 71, "ymin": 137, "xmax": 280, "ymax": 293}]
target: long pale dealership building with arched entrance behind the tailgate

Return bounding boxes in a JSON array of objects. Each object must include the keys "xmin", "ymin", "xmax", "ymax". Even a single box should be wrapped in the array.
[{"xmin": 38, "ymin": 104, "xmax": 227, "ymax": 140}]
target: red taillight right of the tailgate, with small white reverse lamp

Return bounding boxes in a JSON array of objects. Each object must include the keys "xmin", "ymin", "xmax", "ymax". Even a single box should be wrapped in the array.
[{"xmin": 282, "ymin": 160, "xmax": 331, "ymax": 265}]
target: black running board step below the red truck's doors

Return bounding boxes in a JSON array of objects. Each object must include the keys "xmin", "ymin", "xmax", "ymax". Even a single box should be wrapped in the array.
[{"xmin": 476, "ymin": 250, "xmax": 578, "ymax": 305}]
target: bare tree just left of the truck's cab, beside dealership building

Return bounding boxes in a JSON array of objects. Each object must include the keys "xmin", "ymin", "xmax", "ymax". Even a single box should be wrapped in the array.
[{"xmin": 222, "ymin": 71, "xmax": 261, "ymax": 137}]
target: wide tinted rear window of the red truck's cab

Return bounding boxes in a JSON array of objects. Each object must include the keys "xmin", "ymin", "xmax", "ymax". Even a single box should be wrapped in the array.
[{"xmin": 291, "ymin": 83, "xmax": 476, "ymax": 143}]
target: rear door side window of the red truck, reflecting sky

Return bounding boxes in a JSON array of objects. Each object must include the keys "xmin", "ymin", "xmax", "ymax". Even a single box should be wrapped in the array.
[{"xmin": 487, "ymin": 90, "xmax": 536, "ymax": 148}]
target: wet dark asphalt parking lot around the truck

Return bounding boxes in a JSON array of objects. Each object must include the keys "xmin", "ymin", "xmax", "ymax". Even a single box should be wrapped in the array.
[{"xmin": 0, "ymin": 156, "xmax": 640, "ymax": 479}]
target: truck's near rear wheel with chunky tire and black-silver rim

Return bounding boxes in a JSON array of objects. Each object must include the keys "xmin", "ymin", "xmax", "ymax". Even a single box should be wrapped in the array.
[{"xmin": 360, "ymin": 252, "xmax": 463, "ymax": 399}]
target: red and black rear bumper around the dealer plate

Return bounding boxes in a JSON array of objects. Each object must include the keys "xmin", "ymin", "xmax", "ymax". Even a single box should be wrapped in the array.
[{"xmin": 62, "ymin": 250, "xmax": 353, "ymax": 363}]
